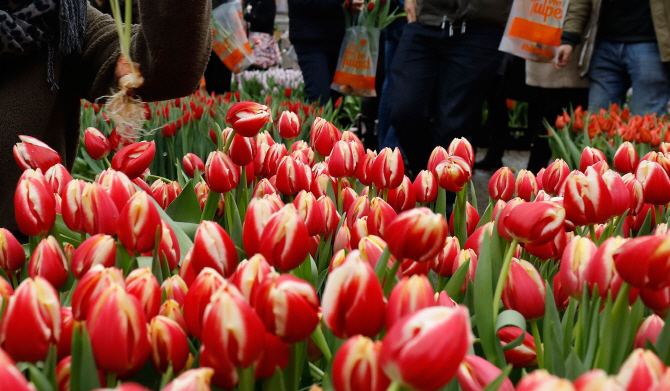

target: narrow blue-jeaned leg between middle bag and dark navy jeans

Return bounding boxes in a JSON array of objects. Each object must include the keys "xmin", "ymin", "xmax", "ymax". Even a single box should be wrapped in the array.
[{"xmin": 377, "ymin": 20, "xmax": 407, "ymax": 149}]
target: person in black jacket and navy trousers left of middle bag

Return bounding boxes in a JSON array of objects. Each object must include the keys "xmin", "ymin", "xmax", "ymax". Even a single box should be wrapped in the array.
[{"xmin": 288, "ymin": 0, "xmax": 364, "ymax": 105}]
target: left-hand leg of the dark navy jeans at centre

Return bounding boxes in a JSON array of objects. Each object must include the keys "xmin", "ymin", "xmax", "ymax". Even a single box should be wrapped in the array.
[{"xmin": 391, "ymin": 22, "xmax": 444, "ymax": 175}]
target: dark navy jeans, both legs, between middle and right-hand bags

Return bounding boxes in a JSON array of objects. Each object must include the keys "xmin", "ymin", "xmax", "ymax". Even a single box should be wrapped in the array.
[{"xmin": 391, "ymin": 22, "xmax": 503, "ymax": 175}]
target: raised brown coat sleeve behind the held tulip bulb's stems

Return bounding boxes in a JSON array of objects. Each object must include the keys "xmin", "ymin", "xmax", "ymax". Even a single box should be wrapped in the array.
[{"xmin": 78, "ymin": 0, "xmax": 212, "ymax": 102}]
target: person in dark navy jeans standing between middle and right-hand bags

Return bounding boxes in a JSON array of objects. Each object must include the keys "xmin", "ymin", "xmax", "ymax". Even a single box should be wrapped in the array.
[{"xmin": 391, "ymin": 0, "xmax": 513, "ymax": 175}]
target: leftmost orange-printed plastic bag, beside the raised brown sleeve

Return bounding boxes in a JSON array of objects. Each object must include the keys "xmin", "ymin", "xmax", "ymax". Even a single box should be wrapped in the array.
[{"xmin": 212, "ymin": 1, "xmax": 256, "ymax": 73}]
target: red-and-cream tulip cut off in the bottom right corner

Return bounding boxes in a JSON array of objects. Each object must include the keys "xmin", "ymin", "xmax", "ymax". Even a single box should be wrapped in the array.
[{"xmin": 616, "ymin": 349, "xmax": 665, "ymax": 390}]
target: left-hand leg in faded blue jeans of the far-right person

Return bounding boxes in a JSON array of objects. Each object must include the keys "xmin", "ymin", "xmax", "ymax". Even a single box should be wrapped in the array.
[{"xmin": 588, "ymin": 42, "xmax": 630, "ymax": 111}]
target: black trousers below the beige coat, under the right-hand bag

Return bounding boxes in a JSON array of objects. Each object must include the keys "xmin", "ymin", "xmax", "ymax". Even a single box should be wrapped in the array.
[{"xmin": 528, "ymin": 87, "xmax": 589, "ymax": 174}]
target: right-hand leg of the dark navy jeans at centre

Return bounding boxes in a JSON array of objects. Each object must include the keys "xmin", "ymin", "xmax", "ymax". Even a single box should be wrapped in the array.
[{"xmin": 434, "ymin": 28, "xmax": 503, "ymax": 153}]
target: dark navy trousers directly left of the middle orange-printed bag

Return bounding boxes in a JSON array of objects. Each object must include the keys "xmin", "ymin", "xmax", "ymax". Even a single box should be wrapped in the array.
[{"xmin": 293, "ymin": 42, "xmax": 340, "ymax": 106}]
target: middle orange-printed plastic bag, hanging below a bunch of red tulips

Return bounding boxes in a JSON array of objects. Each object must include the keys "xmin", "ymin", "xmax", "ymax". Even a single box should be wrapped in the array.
[{"xmin": 330, "ymin": 26, "xmax": 379, "ymax": 97}]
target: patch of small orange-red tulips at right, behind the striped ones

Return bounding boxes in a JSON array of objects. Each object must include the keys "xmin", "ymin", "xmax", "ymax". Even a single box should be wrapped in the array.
[{"xmin": 545, "ymin": 104, "xmax": 670, "ymax": 168}]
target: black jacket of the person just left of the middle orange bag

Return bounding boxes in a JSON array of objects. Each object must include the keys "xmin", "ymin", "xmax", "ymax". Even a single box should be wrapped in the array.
[{"xmin": 288, "ymin": 0, "xmax": 344, "ymax": 45}]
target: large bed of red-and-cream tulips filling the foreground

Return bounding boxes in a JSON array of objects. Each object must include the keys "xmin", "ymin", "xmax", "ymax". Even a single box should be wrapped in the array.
[{"xmin": 6, "ymin": 91, "xmax": 670, "ymax": 391}]
